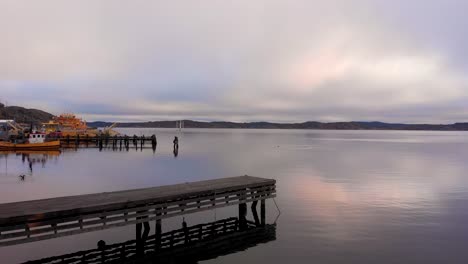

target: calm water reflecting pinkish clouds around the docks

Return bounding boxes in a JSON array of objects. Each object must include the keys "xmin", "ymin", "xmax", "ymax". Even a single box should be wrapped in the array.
[{"xmin": 0, "ymin": 129, "xmax": 468, "ymax": 263}]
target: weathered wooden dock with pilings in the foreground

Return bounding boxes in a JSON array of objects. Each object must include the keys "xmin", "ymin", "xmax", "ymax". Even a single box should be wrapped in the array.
[{"xmin": 0, "ymin": 176, "xmax": 276, "ymax": 246}]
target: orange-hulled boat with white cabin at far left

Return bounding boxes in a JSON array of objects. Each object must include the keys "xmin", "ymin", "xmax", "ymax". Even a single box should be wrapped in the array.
[{"xmin": 0, "ymin": 132, "xmax": 60, "ymax": 151}]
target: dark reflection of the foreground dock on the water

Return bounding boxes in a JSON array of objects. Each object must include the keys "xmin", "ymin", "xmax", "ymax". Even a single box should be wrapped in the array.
[{"xmin": 22, "ymin": 217, "xmax": 276, "ymax": 264}]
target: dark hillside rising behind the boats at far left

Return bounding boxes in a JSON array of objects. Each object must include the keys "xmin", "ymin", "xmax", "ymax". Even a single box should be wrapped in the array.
[{"xmin": 0, "ymin": 103, "xmax": 53, "ymax": 125}]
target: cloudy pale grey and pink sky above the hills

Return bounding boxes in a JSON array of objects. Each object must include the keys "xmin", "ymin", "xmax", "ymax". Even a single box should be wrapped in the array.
[{"xmin": 0, "ymin": 0, "xmax": 468, "ymax": 123}]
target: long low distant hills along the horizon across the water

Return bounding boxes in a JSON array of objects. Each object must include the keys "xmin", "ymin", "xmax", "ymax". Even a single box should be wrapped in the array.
[{"xmin": 88, "ymin": 120, "xmax": 468, "ymax": 131}]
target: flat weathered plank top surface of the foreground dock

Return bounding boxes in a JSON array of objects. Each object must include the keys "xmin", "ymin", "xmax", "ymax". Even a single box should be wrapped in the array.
[{"xmin": 0, "ymin": 176, "xmax": 275, "ymax": 225}]
